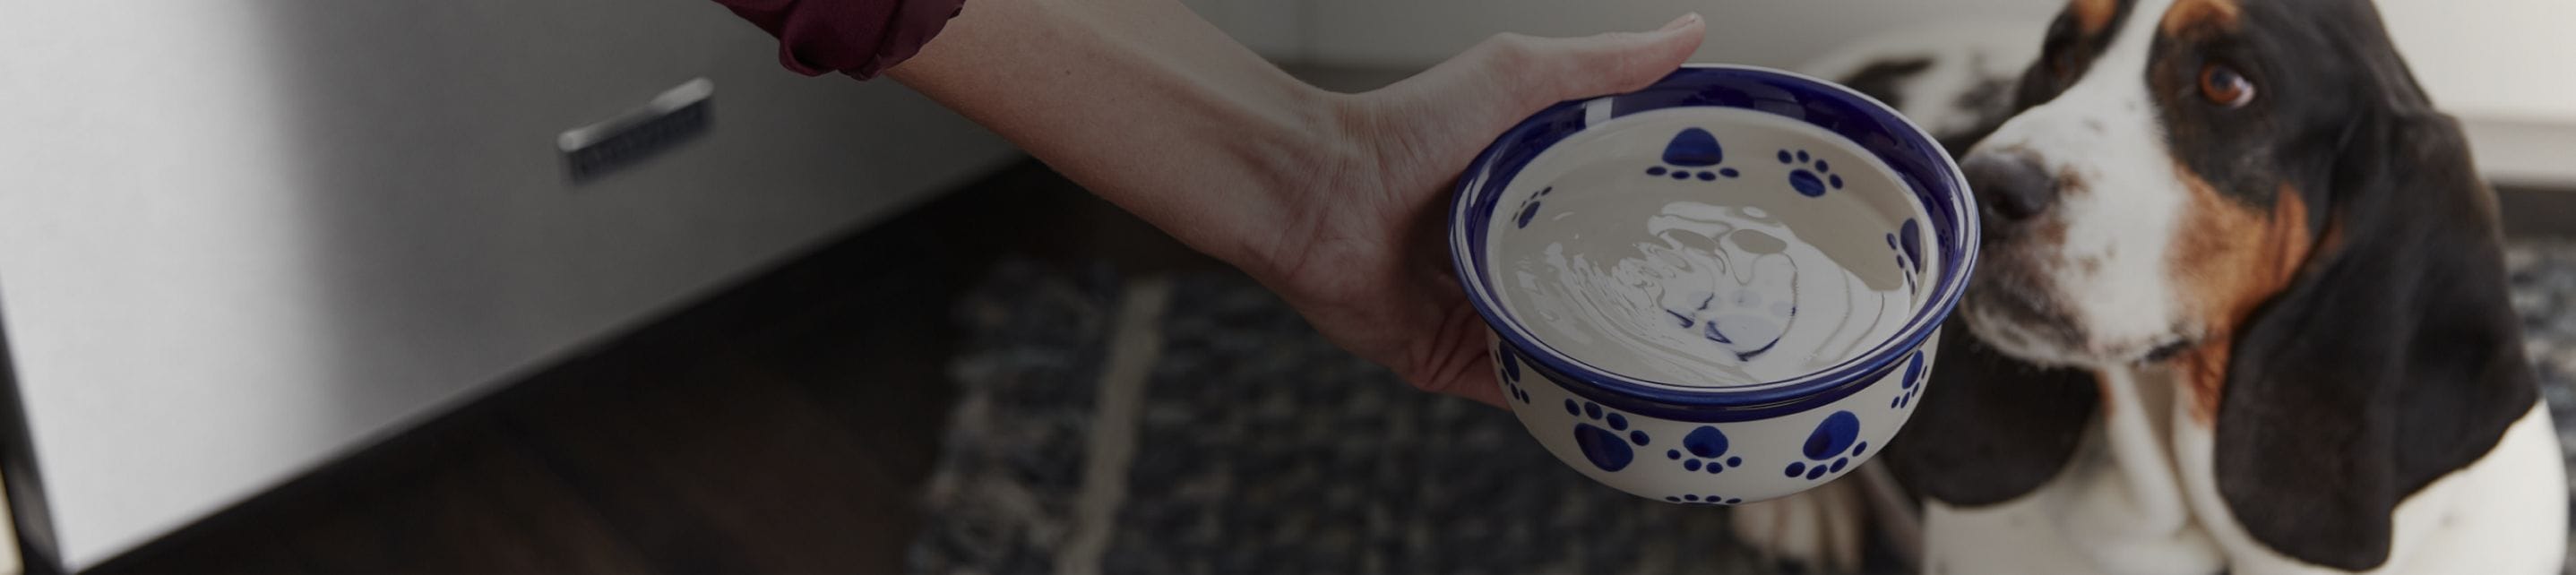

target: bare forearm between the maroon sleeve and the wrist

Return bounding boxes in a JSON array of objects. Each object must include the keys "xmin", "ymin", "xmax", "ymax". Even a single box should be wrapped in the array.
[{"xmin": 889, "ymin": 0, "xmax": 1342, "ymax": 266}]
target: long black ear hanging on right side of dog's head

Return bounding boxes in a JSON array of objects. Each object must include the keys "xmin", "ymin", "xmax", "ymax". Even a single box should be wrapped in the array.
[{"xmin": 2213, "ymin": 106, "xmax": 2537, "ymax": 570}]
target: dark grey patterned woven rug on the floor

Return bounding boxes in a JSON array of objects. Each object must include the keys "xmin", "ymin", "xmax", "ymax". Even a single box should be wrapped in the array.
[{"xmin": 907, "ymin": 245, "xmax": 2576, "ymax": 572}]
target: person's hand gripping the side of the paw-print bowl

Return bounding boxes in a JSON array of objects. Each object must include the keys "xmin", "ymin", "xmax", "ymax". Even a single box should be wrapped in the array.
[{"xmin": 1245, "ymin": 13, "xmax": 1705, "ymax": 405}]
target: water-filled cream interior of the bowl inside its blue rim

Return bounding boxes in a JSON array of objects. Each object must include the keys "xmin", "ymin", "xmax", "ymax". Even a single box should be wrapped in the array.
[{"xmin": 1486, "ymin": 108, "xmax": 1940, "ymax": 387}]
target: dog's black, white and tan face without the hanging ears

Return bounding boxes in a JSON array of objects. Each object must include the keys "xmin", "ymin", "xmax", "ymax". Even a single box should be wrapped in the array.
[{"xmin": 1963, "ymin": 0, "xmax": 2432, "ymax": 366}]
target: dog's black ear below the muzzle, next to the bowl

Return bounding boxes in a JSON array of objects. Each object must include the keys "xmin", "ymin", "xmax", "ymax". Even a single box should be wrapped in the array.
[{"xmin": 1881, "ymin": 320, "xmax": 2102, "ymax": 508}]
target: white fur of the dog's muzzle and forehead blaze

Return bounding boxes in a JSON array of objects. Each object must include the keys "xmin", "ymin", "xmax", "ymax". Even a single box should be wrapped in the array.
[{"xmin": 1963, "ymin": 0, "xmax": 2187, "ymax": 366}]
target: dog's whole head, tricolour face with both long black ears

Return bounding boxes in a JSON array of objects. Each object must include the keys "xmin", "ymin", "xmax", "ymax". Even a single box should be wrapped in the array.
[{"xmin": 1888, "ymin": 0, "xmax": 2537, "ymax": 570}]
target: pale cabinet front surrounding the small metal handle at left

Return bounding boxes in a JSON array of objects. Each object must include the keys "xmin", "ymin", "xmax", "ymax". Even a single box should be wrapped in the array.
[{"xmin": 0, "ymin": 0, "xmax": 1010, "ymax": 567}]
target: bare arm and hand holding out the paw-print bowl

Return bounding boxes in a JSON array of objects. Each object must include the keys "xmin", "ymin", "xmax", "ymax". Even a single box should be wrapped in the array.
[{"xmin": 889, "ymin": 0, "xmax": 1702, "ymax": 405}]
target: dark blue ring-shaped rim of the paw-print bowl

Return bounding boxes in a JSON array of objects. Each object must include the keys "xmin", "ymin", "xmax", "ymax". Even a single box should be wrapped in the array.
[{"xmin": 1448, "ymin": 64, "xmax": 1978, "ymax": 423}]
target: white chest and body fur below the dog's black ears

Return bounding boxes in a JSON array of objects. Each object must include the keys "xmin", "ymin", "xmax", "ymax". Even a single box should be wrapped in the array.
[{"xmin": 1925, "ymin": 369, "xmax": 2568, "ymax": 575}]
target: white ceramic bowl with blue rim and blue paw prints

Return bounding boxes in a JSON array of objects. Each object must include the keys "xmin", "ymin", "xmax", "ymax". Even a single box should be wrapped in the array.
[{"xmin": 1451, "ymin": 64, "xmax": 1978, "ymax": 505}]
